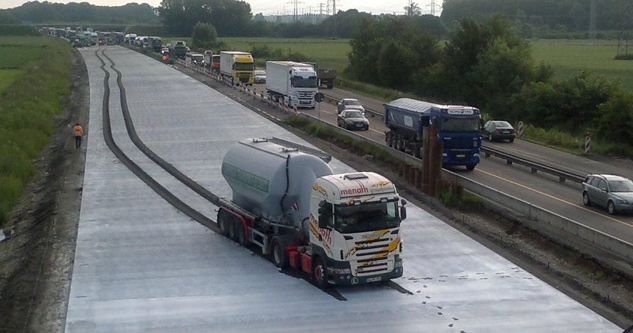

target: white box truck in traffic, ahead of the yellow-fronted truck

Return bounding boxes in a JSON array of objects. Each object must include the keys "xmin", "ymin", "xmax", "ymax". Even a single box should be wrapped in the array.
[{"xmin": 266, "ymin": 61, "xmax": 319, "ymax": 108}]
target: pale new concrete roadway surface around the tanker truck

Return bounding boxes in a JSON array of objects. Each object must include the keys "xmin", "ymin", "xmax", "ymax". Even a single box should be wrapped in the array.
[{"xmin": 66, "ymin": 47, "xmax": 622, "ymax": 333}]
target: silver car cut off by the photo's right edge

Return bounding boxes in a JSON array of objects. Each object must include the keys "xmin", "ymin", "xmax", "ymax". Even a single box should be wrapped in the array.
[{"xmin": 582, "ymin": 174, "xmax": 633, "ymax": 214}]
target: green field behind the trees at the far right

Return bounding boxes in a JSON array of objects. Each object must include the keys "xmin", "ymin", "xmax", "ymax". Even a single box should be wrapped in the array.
[{"xmin": 531, "ymin": 40, "xmax": 633, "ymax": 90}]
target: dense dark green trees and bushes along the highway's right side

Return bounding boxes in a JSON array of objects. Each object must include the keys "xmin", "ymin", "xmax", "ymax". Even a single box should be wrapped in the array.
[{"xmin": 346, "ymin": 15, "xmax": 633, "ymax": 156}]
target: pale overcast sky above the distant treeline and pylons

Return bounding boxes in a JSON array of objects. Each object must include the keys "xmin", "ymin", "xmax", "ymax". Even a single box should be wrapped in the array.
[{"xmin": 0, "ymin": 0, "xmax": 443, "ymax": 15}]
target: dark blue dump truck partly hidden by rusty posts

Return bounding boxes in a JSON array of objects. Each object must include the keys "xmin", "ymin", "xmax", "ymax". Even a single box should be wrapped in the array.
[{"xmin": 385, "ymin": 98, "xmax": 481, "ymax": 170}]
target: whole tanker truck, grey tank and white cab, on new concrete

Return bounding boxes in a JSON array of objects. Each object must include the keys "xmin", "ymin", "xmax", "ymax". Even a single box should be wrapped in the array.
[{"xmin": 217, "ymin": 138, "xmax": 406, "ymax": 287}]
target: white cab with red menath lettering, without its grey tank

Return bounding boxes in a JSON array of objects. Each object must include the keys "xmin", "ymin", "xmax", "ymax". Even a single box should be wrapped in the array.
[{"xmin": 310, "ymin": 172, "xmax": 406, "ymax": 284}]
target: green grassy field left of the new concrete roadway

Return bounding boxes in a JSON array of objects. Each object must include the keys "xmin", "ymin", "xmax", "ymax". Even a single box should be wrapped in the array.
[{"xmin": 0, "ymin": 36, "xmax": 72, "ymax": 226}]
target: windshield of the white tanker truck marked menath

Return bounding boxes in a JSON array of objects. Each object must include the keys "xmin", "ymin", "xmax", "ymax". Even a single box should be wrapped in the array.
[{"xmin": 334, "ymin": 200, "xmax": 400, "ymax": 233}]
